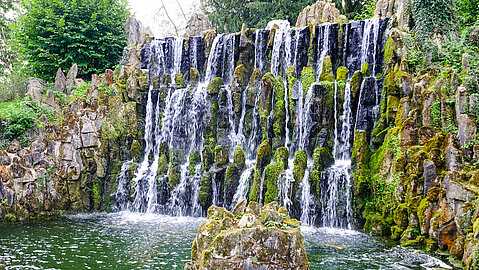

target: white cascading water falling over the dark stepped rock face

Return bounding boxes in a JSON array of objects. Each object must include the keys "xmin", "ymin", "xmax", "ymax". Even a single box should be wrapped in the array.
[{"xmin": 114, "ymin": 19, "xmax": 385, "ymax": 228}]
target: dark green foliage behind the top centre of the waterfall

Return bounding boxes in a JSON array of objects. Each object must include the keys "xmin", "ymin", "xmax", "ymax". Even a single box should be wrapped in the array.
[{"xmin": 205, "ymin": 0, "xmax": 316, "ymax": 33}]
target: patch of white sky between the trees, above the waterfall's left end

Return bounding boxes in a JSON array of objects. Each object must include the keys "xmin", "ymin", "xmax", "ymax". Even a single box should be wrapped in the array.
[{"xmin": 128, "ymin": 0, "xmax": 200, "ymax": 37}]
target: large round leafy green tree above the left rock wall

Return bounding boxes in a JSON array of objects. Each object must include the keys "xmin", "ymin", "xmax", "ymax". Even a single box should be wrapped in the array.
[{"xmin": 12, "ymin": 0, "xmax": 130, "ymax": 79}]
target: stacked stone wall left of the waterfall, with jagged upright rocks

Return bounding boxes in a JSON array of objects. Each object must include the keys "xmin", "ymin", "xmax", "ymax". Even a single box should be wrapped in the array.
[{"xmin": 0, "ymin": 18, "xmax": 148, "ymax": 219}]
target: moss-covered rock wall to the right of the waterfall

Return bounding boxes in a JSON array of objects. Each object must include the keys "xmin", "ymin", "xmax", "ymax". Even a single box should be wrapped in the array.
[{"xmin": 353, "ymin": 7, "xmax": 479, "ymax": 269}]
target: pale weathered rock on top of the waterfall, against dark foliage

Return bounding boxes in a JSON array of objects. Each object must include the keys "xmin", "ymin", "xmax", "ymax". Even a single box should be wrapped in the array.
[{"xmin": 296, "ymin": 0, "xmax": 348, "ymax": 28}]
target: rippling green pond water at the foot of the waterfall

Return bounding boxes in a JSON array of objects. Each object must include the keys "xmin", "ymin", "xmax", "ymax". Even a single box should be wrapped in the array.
[{"xmin": 0, "ymin": 212, "xmax": 451, "ymax": 270}]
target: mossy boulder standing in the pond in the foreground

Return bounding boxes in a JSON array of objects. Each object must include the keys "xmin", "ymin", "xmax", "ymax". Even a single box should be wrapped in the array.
[{"xmin": 185, "ymin": 201, "xmax": 309, "ymax": 270}]
